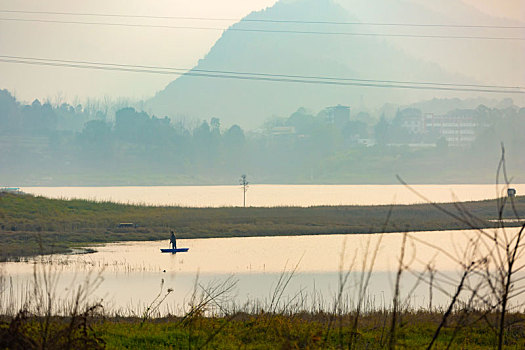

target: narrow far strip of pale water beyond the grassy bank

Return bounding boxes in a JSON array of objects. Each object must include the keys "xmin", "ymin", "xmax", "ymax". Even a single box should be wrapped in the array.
[{"xmin": 22, "ymin": 184, "xmax": 525, "ymax": 207}]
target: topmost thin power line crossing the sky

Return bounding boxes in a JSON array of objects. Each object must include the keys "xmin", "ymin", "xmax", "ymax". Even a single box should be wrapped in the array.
[{"xmin": 0, "ymin": 10, "xmax": 525, "ymax": 29}]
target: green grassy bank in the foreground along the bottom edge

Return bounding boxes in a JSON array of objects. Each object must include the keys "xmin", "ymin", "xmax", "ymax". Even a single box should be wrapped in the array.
[{"xmin": 0, "ymin": 310, "xmax": 525, "ymax": 349}]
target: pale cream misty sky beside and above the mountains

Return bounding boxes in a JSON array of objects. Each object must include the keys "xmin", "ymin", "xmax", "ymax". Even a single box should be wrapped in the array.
[{"xmin": 0, "ymin": 0, "xmax": 525, "ymax": 102}]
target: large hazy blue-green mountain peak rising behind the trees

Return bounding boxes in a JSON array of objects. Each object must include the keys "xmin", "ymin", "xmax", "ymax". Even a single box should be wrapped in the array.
[{"xmin": 145, "ymin": 0, "xmax": 520, "ymax": 128}]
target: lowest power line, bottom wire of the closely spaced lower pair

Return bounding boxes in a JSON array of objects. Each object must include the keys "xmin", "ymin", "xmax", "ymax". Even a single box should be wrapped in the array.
[{"xmin": 0, "ymin": 58, "xmax": 525, "ymax": 94}]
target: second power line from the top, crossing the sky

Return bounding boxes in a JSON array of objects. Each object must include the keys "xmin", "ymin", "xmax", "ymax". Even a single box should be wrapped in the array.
[{"xmin": 0, "ymin": 18, "xmax": 525, "ymax": 41}]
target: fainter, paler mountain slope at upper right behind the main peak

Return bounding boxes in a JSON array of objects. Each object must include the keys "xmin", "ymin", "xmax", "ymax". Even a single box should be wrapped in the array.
[{"xmin": 337, "ymin": 0, "xmax": 525, "ymax": 86}]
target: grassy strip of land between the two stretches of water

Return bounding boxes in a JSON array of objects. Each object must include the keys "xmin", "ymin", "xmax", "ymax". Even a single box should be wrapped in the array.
[{"xmin": 0, "ymin": 193, "xmax": 525, "ymax": 260}]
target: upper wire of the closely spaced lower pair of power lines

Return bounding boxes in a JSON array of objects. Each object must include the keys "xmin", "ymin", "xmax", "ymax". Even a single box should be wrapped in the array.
[{"xmin": 0, "ymin": 55, "xmax": 522, "ymax": 90}]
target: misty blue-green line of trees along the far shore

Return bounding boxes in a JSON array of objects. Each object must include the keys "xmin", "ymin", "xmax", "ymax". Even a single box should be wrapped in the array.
[{"xmin": 0, "ymin": 90, "xmax": 525, "ymax": 184}]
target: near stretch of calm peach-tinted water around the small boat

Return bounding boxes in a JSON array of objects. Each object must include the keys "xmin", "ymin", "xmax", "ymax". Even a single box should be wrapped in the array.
[{"xmin": 0, "ymin": 229, "xmax": 523, "ymax": 315}]
